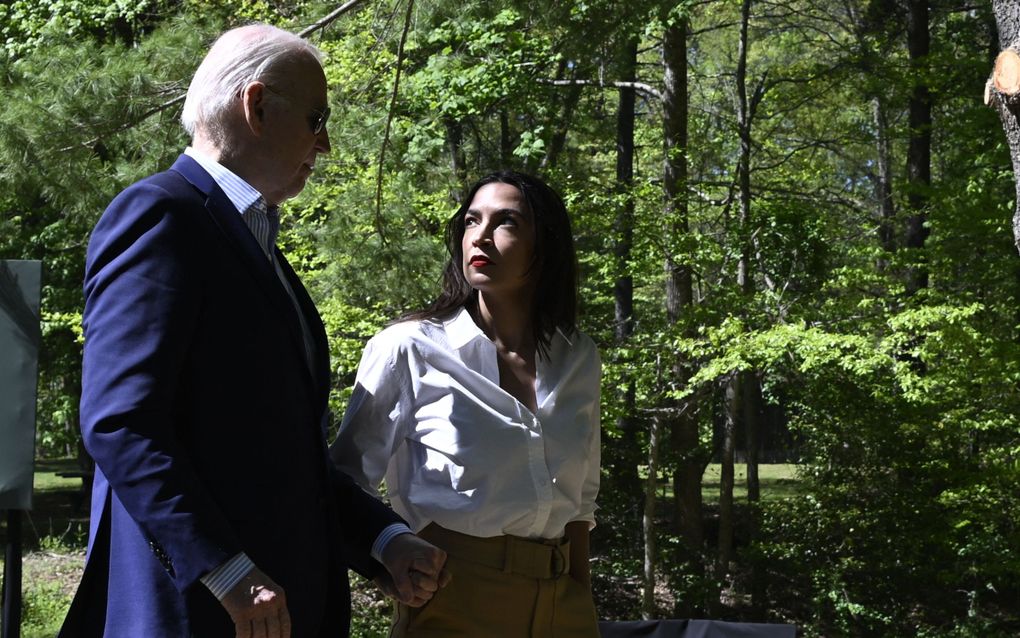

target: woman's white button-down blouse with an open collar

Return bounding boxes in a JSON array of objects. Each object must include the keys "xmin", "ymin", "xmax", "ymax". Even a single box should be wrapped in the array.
[{"xmin": 332, "ymin": 309, "xmax": 601, "ymax": 538}]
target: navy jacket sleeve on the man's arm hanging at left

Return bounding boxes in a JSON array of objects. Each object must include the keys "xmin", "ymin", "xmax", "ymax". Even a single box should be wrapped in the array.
[{"xmin": 82, "ymin": 176, "xmax": 242, "ymax": 591}]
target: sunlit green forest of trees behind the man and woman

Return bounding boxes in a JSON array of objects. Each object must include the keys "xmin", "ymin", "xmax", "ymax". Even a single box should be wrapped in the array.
[{"xmin": 0, "ymin": 0, "xmax": 1020, "ymax": 637}]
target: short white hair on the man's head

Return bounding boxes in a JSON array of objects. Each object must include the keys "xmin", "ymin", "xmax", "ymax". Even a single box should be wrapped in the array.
[{"xmin": 181, "ymin": 24, "xmax": 322, "ymax": 148}]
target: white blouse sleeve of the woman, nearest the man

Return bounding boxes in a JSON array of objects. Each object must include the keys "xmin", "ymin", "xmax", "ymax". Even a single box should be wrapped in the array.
[{"xmin": 329, "ymin": 331, "xmax": 412, "ymax": 496}]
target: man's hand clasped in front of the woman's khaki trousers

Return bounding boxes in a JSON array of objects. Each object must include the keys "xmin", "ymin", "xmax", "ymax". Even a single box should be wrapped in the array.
[{"xmin": 375, "ymin": 534, "xmax": 450, "ymax": 607}]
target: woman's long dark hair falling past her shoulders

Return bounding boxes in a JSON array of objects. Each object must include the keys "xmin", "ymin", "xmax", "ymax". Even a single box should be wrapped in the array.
[{"xmin": 402, "ymin": 170, "xmax": 577, "ymax": 356}]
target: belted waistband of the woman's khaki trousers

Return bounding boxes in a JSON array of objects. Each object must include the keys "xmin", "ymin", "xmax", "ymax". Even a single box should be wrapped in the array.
[{"xmin": 418, "ymin": 523, "xmax": 570, "ymax": 579}]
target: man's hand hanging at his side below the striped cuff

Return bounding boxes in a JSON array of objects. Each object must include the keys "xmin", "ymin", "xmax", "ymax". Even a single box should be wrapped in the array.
[{"xmin": 220, "ymin": 568, "xmax": 291, "ymax": 638}]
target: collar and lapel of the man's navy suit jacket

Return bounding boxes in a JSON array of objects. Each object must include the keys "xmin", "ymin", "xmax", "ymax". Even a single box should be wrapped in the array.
[{"xmin": 170, "ymin": 155, "xmax": 329, "ymax": 395}]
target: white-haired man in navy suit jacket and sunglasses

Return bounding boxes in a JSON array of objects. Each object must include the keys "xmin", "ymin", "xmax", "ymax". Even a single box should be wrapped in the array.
[{"xmin": 61, "ymin": 24, "xmax": 446, "ymax": 638}]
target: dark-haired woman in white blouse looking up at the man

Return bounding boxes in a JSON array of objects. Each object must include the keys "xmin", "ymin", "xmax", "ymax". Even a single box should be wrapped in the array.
[{"xmin": 332, "ymin": 171, "xmax": 600, "ymax": 638}]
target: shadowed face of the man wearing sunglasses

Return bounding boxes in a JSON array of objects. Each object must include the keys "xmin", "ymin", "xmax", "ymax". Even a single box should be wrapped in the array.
[{"xmin": 263, "ymin": 56, "xmax": 329, "ymax": 206}]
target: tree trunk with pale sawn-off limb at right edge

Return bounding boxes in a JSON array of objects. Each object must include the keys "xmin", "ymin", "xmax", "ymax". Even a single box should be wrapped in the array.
[{"xmin": 984, "ymin": 0, "xmax": 1020, "ymax": 252}]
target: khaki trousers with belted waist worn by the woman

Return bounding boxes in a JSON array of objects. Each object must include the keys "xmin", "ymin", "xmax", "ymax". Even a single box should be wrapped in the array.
[{"xmin": 390, "ymin": 525, "xmax": 599, "ymax": 638}]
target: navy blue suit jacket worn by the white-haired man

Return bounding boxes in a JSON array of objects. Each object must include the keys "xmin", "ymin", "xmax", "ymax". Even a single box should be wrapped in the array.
[{"xmin": 61, "ymin": 155, "xmax": 400, "ymax": 638}]
